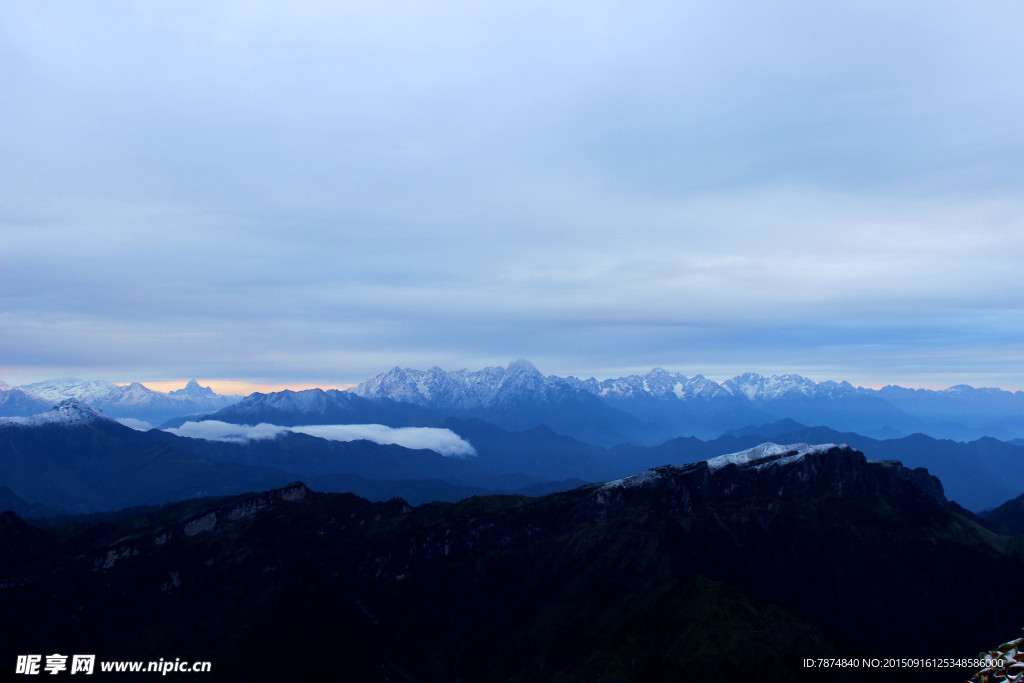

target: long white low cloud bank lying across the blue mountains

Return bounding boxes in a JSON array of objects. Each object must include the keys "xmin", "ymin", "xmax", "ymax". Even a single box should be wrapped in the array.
[{"xmin": 165, "ymin": 420, "xmax": 476, "ymax": 458}]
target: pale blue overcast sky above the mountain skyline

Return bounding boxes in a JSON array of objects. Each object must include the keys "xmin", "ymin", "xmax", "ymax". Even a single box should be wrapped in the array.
[{"xmin": 0, "ymin": 0, "xmax": 1024, "ymax": 390}]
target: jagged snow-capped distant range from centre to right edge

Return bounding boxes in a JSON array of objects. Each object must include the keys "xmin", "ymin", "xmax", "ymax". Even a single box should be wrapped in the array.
[{"xmin": 351, "ymin": 360, "xmax": 1024, "ymax": 445}]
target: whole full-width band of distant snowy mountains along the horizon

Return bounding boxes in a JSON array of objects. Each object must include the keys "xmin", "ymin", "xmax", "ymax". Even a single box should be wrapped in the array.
[{"xmin": 0, "ymin": 360, "xmax": 1024, "ymax": 446}]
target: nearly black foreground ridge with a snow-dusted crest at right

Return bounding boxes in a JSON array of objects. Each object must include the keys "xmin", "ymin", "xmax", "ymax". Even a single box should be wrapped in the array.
[{"xmin": 0, "ymin": 445, "xmax": 1024, "ymax": 681}]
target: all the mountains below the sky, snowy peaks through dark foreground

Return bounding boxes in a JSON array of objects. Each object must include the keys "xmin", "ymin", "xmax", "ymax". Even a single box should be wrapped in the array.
[{"xmin": 0, "ymin": 360, "xmax": 1024, "ymax": 683}]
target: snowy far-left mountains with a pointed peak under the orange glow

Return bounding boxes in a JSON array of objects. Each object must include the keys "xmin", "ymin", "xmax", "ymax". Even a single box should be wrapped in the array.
[{"xmin": 0, "ymin": 378, "xmax": 242, "ymax": 424}]
